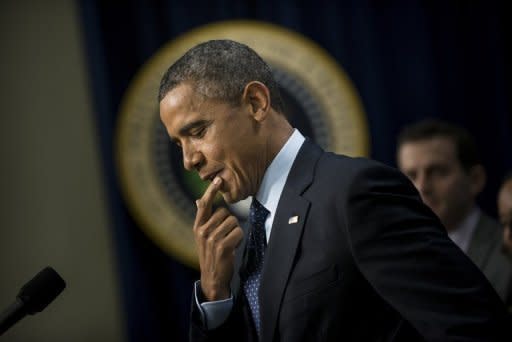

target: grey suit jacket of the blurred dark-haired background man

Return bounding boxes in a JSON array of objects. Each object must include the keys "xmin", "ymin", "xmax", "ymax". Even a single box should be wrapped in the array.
[{"xmin": 467, "ymin": 214, "xmax": 512, "ymax": 308}]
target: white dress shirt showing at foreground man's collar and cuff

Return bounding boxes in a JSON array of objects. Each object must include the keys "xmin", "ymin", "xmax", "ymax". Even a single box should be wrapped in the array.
[{"xmin": 194, "ymin": 129, "xmax": 305, "ymax": 329}]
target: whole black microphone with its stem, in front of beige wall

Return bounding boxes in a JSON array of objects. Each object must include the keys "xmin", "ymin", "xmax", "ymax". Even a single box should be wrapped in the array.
[{"xmin": 0, "ymin": 267, "xmax": 66, "ymax": 335}]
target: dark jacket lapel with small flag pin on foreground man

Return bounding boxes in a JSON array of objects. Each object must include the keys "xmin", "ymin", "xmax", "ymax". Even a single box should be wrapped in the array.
[{"xmin": 260, "ymin": 140, "xmax": 322, "ymax": 341}]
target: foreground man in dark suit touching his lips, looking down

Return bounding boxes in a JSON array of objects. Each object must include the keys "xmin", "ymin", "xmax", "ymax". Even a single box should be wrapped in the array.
[{"xmin": 159, "ymin": 40, "xmax": 508, "ymax": 341}]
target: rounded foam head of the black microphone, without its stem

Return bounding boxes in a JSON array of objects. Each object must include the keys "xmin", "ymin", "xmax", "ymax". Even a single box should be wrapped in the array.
[{"xmin": 18, "ymin": 267, "xmax": 66, "ymax": 315}]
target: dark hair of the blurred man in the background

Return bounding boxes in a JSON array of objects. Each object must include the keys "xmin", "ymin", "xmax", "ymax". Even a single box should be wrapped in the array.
[{"xmin": 397, "ymin": 119, "xmax": 481, "ymax": 171}]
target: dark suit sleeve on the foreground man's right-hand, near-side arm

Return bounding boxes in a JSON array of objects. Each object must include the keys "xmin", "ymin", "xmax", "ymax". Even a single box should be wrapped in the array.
[{"xmin": 340, "ymin": 164, "xmax": 512, "ymax": 341}]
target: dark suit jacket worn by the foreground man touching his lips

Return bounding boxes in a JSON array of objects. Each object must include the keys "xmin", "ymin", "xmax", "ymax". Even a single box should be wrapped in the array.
[{"xmin": 190, "ymin": 140, "xmax": 512, "ymax": 342}]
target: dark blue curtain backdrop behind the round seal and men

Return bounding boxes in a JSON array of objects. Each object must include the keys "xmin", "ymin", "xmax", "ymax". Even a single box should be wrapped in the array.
[{"xmin": 80, "ymin": 0, "xmax": 512, "ymax": 341}]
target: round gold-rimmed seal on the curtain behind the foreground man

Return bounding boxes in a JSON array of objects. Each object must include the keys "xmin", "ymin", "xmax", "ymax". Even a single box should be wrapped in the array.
[{"xmin": 116, "ymin": 21, "xmax": 369, "ymax": 267}]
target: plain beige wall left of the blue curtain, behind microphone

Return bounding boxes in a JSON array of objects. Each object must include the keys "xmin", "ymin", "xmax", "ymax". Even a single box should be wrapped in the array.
[{"xmin": 0, "ymin": 0, "xmax": 124, "ymax": 342}]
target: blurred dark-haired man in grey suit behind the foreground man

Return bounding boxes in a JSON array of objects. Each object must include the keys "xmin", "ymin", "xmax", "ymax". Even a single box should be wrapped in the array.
[{"xmin": 397, "ymin": 119, "xmax": 512, "ymax": 305}]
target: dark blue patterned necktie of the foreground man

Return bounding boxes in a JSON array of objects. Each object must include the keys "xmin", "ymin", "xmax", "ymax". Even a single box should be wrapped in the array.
[{"xmin": 244, "ymin": 198, "xmax": 270, "ymax": 335}]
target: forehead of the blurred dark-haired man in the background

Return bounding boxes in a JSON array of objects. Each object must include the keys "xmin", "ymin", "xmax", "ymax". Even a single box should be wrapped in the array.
[{"xmin": 398, "ymin": 137, "xmax": 457, "ymax": 167}]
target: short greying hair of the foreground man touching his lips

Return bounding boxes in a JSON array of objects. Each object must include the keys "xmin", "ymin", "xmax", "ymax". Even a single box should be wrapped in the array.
[{"xmin": 158, "ymin": 40, "xmax": 283, "ymax": 112}]
